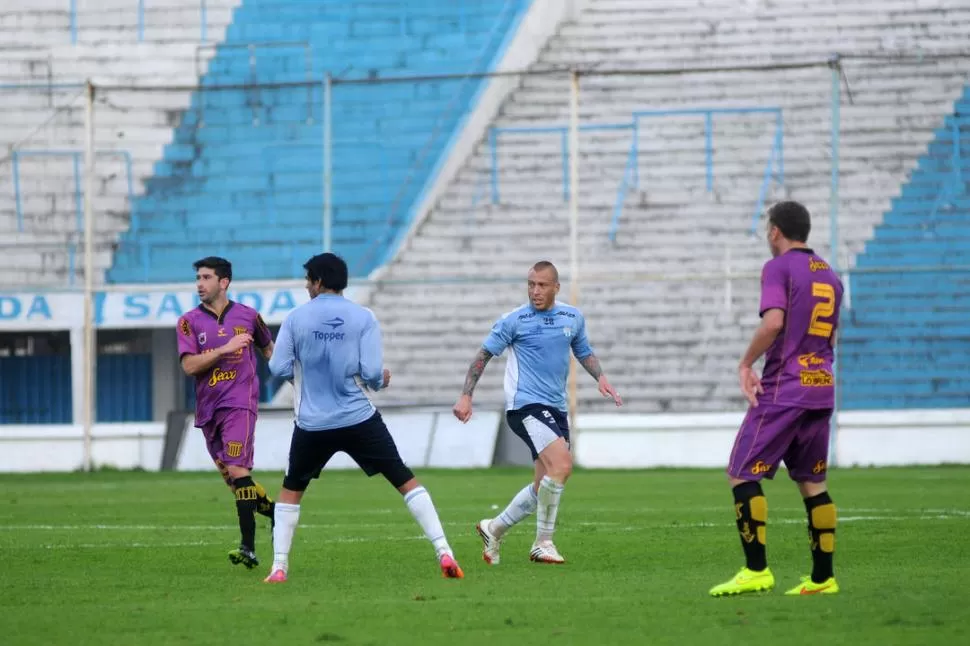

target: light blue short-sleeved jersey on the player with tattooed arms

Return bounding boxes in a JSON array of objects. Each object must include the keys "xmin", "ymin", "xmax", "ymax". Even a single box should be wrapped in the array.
[{"xmin": 482, "ymin": 301, "xmax": 593, "ymax": 411}]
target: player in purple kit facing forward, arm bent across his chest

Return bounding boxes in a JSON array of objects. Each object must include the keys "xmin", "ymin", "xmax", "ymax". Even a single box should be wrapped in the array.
[{"xmin": 176, "ymin": 257, "xmax": 274, "ymax": 569}]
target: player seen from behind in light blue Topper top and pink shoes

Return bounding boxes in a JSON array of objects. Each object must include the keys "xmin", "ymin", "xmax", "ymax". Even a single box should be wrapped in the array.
[{"xmin": 266, "ymin": 253, "xmax": 464, "ymax": 583}]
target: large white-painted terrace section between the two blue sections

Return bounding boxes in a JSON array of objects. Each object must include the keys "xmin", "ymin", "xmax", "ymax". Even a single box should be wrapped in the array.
[{"xmin": 364, "ymin": 0, "xmax": 970, "ymax": 412}]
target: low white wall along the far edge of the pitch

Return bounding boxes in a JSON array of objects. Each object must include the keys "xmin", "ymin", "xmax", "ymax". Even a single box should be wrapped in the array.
[{"xmin": 0, "ymin": 408, "xmax": 970, "ymax": 472}]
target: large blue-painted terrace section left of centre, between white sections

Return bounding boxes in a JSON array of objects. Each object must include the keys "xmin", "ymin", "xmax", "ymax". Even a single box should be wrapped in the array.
[{"xmin": 108, "ymin": 0, "xmax": 529, "ymax": 282}]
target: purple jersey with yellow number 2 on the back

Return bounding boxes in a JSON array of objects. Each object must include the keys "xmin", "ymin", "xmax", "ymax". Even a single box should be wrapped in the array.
[{"xmin": 758, "ymin": 249, "xmax": 842, "ymax": 409}]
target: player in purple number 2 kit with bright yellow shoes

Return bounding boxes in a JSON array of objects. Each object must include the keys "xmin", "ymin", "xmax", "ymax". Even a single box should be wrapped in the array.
[{"xmin": 711, "ymin": 202, "xmax": 842, "ymax": 596}]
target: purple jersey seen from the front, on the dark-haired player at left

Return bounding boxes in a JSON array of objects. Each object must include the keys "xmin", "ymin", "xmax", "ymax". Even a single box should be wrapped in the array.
[{"xmin": 176, "ymin": 301, "xmax": 273, "ymax": 428}]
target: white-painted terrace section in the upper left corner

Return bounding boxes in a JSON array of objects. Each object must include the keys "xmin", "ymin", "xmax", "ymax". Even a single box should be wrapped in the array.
[{"xmin": 0, "ymin": 0, "xmax": 238, "ymax": 288}]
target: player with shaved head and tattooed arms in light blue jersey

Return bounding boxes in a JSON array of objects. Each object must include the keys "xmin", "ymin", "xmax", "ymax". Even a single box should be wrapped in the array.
[{"xmin": 454, "ymin": 261, "xmax": 623, "ymax": 565}]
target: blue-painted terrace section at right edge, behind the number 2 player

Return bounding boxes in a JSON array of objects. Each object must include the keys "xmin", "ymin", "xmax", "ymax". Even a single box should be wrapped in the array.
[{"xmin": 839, "ymin": 86, "xmax": 970, "ymax": 409}]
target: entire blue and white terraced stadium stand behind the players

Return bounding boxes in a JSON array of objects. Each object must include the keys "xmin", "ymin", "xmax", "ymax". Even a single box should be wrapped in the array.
[{"xmin": 0, "ymin": 0, "xmax": 970, "ymax": 417}]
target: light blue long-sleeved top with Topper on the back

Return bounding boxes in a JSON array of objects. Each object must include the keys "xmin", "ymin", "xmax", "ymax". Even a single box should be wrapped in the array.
[{"xmin": 269, "ymin": 294, "xmax": 384, "ymax": 431}]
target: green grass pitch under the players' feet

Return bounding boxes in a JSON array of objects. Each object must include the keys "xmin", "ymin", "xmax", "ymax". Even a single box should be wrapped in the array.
[{"xmin": 0, "ymin": 467, "xmax": 970, "ymax": 646}]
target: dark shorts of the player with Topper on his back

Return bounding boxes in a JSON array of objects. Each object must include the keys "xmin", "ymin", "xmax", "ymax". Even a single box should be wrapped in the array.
[{"xmin": 283, "ymin": 412, "xmax": 414, "ymax": 491}]
